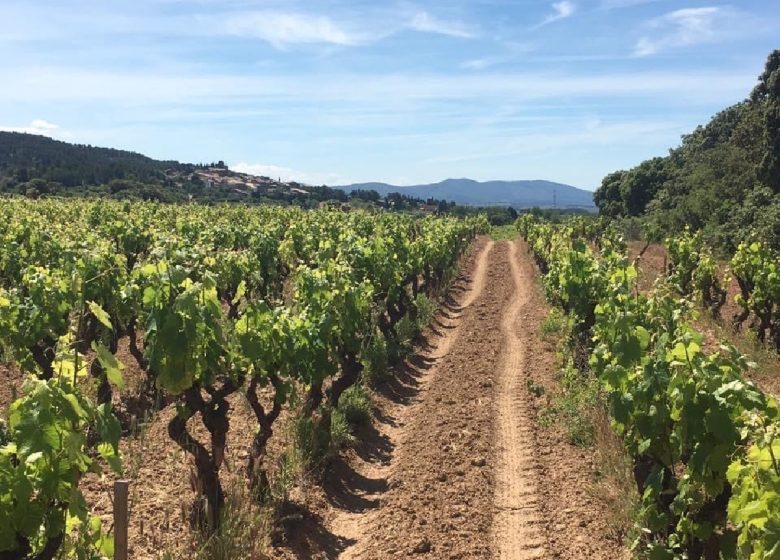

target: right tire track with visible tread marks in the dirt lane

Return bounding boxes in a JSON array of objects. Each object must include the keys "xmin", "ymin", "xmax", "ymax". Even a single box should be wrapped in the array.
[{"xmin": 491, "ymin": 242, "xmax": 547, "ymax": 560}]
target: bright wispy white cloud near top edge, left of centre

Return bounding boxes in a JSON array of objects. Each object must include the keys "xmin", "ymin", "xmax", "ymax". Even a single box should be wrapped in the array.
[{"xmin": 224, "ymin": 11, "xmax": 363, "ymax": 48}]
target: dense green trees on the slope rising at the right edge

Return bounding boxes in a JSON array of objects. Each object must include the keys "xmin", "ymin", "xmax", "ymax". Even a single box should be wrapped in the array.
[{"xmin": 594, "ymin": 50, "xmax": 780, "ymax": 251}]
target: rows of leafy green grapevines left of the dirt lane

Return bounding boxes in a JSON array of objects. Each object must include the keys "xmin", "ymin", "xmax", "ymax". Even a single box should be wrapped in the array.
[{"xmin": 0, "ymin": 200, "xmax": 483, "ymax": 559}]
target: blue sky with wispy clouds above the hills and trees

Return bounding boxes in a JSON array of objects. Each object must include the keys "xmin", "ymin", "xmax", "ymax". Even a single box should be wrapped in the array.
[{"xmin": 0, "ymin": 0, "xmax": 780, "ymax": 189}]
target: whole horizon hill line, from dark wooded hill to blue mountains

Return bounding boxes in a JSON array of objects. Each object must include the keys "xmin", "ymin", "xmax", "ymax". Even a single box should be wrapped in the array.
[{"xmin": 0, "ymin": 131, "xmax": 595, "ymax": 209}]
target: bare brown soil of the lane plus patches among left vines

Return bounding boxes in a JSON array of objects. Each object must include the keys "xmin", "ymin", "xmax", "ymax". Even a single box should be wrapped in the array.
[{"xmin": 0, "ymin": 238, "xmax": 627, "ymax": 560}]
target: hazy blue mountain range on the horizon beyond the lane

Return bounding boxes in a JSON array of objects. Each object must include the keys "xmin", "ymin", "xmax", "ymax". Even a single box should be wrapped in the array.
[{"xmin": 334, "ymin": 179, "xmax": 595, "ymax": 209}]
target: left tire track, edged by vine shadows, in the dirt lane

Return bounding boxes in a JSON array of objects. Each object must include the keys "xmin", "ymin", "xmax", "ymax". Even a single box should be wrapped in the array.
[{"xmin": 329, "ymin": 240, "xmax": 495, "ymax": 560}]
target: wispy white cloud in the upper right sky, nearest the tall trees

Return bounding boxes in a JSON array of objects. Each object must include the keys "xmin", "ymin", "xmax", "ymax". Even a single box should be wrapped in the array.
[{"xmin": 634, "ymin": 6, "xmax": 734, "ymax": 56}]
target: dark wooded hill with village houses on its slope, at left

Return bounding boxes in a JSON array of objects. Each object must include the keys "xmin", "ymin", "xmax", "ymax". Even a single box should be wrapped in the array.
[{"xmin": 0, "ymin": 132, "xmax": 348, "ymax": 207}]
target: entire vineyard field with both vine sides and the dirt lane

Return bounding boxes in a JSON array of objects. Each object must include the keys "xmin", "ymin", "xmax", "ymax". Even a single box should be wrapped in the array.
[{"xmin": 0, "ymin": 199, "xmax": 780, "ymax": 560}]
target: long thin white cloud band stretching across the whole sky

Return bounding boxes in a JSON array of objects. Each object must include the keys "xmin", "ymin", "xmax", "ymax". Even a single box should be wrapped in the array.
[{"xmin": 0, "ymin": 67, "xmax": 755, "ymax": 106}]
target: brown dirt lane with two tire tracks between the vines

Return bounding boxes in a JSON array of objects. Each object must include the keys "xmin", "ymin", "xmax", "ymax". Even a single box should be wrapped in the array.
[{"xmin": 310, "ymin": 240, "xmax": 625, "ymax": 560}]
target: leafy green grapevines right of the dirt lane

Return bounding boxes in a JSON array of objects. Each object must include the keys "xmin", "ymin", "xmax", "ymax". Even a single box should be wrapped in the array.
[{"xmin": 518, "ymin": 217, "xmax": 780, "ymax": 559}]
